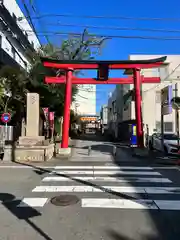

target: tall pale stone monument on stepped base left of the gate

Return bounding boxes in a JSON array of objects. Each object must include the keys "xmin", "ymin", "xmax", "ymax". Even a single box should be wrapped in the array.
[{"xmin": 3, "ymin": 93, "xmax": 54, "ymax": 162}]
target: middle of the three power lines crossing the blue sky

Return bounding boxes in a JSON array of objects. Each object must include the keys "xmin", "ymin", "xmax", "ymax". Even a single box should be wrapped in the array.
[{"xmin": 39, "ymin": 23, "xmax": 180, "ymax": 33}]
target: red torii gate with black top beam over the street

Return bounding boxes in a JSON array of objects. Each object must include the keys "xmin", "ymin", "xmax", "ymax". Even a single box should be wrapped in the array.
[{"xmin": 41, "ymin": 57, "xmax": 166, "ymax": 148}]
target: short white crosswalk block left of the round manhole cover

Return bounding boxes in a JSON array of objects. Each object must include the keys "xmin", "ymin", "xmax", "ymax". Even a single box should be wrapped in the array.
[{"xmin": 18, "ymin": 198, "xmax": 48, "ymax": 207}]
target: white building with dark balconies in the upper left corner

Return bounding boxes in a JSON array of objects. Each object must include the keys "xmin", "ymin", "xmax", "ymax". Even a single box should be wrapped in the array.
[{"xmin": 0, "ymin": 0, "xmax": 40, "ymax": 69}]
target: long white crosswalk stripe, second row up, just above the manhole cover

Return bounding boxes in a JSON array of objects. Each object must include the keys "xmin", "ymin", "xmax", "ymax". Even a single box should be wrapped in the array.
[{"xmin": 32, "ymin": 186, "xmax": 180, "ymax": 194}]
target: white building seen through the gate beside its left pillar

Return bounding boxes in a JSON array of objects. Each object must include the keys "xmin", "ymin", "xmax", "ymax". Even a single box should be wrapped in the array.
[{"xmin": 71, "ymin": 84, "xmax": 96, "ymax": 116}]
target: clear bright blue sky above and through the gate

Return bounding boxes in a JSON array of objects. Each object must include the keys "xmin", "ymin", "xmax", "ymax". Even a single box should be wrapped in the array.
[{"xmin": 18, "ymin": 0, "xmax": 180, "ymax": 112}]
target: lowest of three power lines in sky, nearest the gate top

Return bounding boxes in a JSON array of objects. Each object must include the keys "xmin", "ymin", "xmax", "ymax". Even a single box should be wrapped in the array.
[{"xmin": 23, "ymin": 31, "xmax": 180, "ymax": 41}]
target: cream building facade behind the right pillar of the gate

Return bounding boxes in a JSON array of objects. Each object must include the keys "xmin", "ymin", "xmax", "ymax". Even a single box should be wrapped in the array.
[{"xmin": 127, "ymin": 55, "xmax": 180, "ymax": 134}]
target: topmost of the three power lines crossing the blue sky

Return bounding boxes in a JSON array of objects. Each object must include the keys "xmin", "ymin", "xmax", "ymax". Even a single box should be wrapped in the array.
[{"xmin": 20, "ymin": 13, "xmax": 180, "ymax": 22}]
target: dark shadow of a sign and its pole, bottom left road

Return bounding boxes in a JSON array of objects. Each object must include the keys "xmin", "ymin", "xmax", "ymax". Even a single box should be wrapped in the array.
[{"xmin": 0, "ymin": 193, "xmax": 53, "ymax": 240}]
